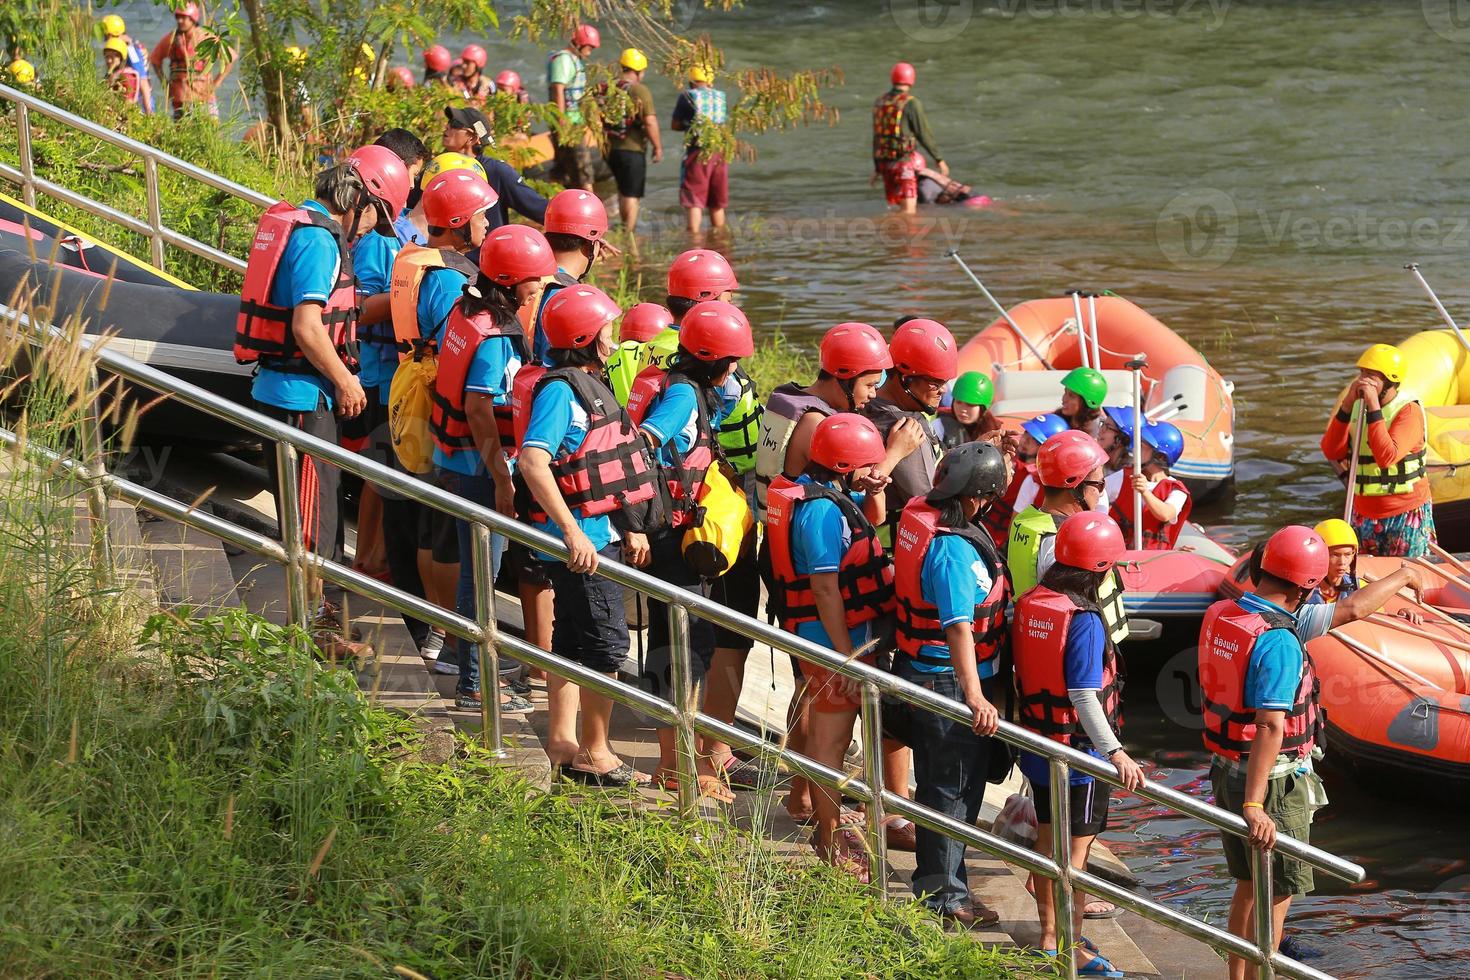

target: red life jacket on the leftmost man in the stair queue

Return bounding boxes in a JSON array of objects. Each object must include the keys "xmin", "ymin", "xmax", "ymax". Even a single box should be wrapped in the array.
[{"xmin": 235, "ymin": 201, "xmax": 357, "ymax": 375}]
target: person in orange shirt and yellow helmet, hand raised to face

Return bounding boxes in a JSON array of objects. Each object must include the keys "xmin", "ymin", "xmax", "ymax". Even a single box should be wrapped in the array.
[{"xmin": 1322, "ymin": 344, "xmax": 1435, "ymax": 558}]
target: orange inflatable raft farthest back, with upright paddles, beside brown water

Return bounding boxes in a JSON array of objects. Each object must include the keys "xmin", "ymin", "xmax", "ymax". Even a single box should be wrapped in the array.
[{"xmin": 960, "ymin": 295, "xmax": 1235, "ymax": 502}]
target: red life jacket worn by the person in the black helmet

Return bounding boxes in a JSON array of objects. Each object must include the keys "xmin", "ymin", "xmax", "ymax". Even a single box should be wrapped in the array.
[{"xmin": 894, "ymin": 497, "xmax": 1011, "ymax": 673}]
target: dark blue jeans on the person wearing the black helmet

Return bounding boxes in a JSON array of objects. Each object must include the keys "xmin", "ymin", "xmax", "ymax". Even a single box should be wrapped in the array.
[{"xmin": 898, "ymin": 654, "xmax": 991, "ymax": 912}]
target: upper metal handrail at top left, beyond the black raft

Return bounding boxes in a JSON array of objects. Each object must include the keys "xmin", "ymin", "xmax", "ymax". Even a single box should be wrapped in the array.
[{"xmin": 0, "ymin": 85, "xmax": 276, "ymax": 272}]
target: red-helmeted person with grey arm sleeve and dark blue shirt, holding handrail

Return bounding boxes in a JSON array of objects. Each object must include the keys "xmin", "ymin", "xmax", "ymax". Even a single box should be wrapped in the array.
[{"xmin": 1011, "ymin": 511, "xmax": 1144, "ymax": 977}]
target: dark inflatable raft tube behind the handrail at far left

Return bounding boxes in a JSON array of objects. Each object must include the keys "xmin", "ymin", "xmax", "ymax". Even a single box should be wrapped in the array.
[{"xmin": 0, "ymin": 250, "xmax": 251, "ymax": 445}]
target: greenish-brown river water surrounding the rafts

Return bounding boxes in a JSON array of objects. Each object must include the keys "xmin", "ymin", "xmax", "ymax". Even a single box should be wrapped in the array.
[{"xmin": 111, "ymin": 0, "xmax": 1470, "ymax": 977}]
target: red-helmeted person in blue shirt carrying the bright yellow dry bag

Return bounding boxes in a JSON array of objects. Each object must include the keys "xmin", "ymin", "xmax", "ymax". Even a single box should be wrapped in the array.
[{"xmin": 628, "ymin": 300, "xmax": 756, "ymax": 802}]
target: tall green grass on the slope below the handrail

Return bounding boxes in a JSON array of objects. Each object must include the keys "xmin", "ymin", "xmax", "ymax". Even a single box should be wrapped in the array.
[{"xmin": 0, "ymin": 295, "xmax": 1040, "ymax": 980}]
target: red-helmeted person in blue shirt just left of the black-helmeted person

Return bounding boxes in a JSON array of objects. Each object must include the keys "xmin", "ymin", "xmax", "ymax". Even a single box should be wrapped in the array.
[{"xmin": 766, "ymin": 411, "xmax": 907, "ymax": 882}]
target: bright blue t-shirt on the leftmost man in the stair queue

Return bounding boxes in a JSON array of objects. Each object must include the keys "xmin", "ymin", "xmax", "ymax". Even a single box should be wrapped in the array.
[{"xmin": 250, "ymin": 201, "xmax": 343, "ymax": 411}]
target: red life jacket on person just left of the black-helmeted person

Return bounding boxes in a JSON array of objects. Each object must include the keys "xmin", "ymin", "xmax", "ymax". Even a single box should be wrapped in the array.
[{"xmin": 766, "ymin": 476, "xmax": 894, "ymax": 633}]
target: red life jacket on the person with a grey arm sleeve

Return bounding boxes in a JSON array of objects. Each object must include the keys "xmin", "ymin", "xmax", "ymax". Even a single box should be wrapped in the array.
[{"xmin": 1011, "ymin": 585, "xmax": 1123, "ymax": 745}]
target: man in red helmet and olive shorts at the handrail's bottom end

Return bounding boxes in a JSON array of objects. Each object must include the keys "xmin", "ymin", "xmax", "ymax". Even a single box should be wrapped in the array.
[{"xmin": 1200, "ymin": 525, "xmax": 1327, "ymax": 980}]
